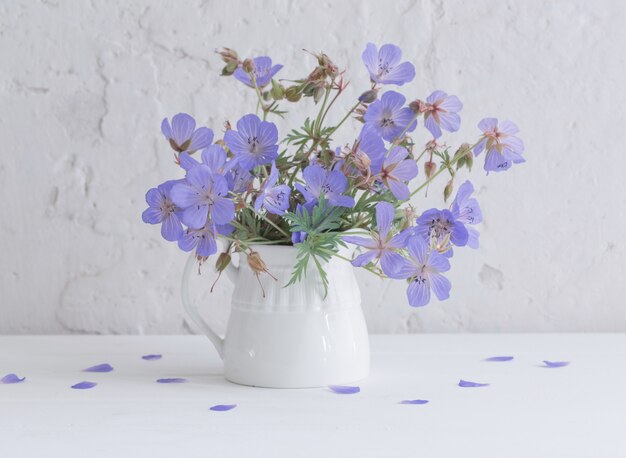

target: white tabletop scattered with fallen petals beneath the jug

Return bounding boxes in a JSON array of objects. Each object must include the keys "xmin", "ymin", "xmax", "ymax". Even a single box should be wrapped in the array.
[{"xmin": 0, "ymin": 334, "xmax": 626, "ymax": 458}]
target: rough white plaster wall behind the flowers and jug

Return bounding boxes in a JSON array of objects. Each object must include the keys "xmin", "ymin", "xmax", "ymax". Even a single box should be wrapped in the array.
[{"xmin": 0, "ymin": 0, "xmax": 626, "ymax": 333}]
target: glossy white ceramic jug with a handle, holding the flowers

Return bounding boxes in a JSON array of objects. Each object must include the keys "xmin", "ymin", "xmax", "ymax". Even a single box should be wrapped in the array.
[{"xmin": 182, "ymin": 245, "xmax": 370, "ymax": 388}]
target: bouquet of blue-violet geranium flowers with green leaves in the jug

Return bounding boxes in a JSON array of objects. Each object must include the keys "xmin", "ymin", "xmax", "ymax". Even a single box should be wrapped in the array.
[{"xmin": 143, "ymin": 43, "xmax": 524, "ymax": 307}]
